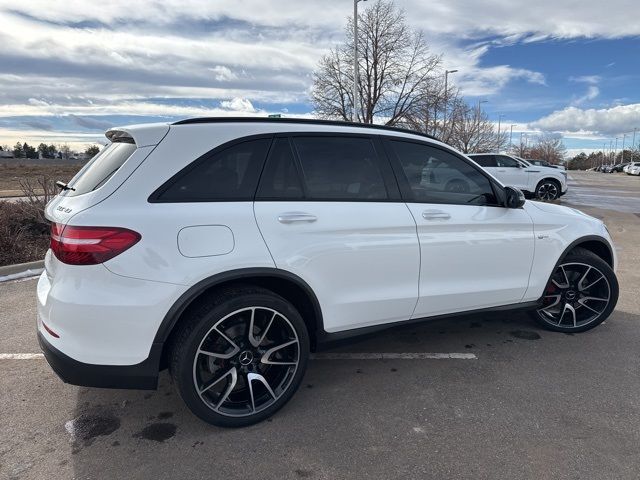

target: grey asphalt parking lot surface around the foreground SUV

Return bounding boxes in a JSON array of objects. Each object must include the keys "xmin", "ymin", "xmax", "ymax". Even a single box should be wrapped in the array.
[{"xmin": 0, "ymin": 172, "xmax": 640, "ymax": 479}]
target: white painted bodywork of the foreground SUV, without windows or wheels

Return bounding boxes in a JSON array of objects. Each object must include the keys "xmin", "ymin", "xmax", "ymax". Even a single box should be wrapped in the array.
[{"xmin": 37, "ymin": 122, "xmax": 611, "ymax": 365}]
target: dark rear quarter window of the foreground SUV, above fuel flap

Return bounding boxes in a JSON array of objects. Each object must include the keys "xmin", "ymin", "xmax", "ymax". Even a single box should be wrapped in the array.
[{"xmin": 157, "ymin": 138, "xmax": 271, "ymax": 202}]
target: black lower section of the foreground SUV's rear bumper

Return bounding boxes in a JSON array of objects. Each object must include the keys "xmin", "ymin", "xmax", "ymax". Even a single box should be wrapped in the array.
[{"xmin": 38, "ymin": 331, "xmax": 162, "ymax": 390}]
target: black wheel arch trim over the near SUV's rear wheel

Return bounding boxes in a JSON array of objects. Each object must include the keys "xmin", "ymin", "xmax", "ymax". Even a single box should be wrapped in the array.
[{"xmin": 153, "ymin": 268, "xmax": 323, "ymax": 368}]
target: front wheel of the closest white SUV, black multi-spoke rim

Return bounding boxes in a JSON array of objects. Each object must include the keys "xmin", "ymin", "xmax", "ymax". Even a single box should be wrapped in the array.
[{"xmin": 531, "ymin": 248, "xmax": 619, "ymax": 333}]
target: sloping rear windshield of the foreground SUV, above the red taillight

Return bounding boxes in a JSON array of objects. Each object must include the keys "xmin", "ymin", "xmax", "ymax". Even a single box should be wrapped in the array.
[{"xmin": 66, "ymin": 143, "xmax": 136, "ymax": 197}]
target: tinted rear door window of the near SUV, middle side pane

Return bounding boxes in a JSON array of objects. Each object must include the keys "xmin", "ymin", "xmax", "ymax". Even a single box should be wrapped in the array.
[{"xmin": 293, "ymin": 136, "xmax": 388, "ymax": 201}]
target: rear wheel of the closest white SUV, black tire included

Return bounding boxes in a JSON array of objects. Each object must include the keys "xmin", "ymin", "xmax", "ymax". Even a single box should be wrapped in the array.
[{"xmin": 169, "ymin": 286, "xmax": 309, "ymax": 427}]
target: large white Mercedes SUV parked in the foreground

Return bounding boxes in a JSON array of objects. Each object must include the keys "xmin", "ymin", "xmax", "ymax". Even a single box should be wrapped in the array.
[{"xmin": 37, "ymin": 119, "xmax": 618, "ymax": 426}]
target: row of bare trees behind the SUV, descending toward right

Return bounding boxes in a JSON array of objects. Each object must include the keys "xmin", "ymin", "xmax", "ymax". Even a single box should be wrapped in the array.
[{"xmin": 311, "ymin": 0, "xmax": 565, "ymax": 163}]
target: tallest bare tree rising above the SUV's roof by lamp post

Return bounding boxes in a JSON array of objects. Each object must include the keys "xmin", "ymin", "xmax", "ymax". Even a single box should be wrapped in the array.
[{"xmin": 311, "ymin": 0, "xmax": 441, "ymax": 125}]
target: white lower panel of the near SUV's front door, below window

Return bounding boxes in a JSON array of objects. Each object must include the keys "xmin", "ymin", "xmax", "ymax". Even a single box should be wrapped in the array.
[{"xmin": 408, "ymin": 203, "xmax": 534, "ymax": 318}]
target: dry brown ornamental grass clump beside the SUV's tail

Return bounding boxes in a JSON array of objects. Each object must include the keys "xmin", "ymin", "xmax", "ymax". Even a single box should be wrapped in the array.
[{"xmin": 0, "ymin": 176, "xmax": 56, "ymax": 266}]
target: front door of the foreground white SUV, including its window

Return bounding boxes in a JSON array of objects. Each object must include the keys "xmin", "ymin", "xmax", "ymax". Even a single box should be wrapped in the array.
[{"xmin": 384, "ymin": 138, "xmax": 534, "ymax": 318}]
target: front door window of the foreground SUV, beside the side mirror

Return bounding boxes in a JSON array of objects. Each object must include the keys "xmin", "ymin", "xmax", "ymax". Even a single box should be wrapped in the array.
[{"xmin": 389, "ymin": 140, "xmax": 498, "ymax": 205}]
